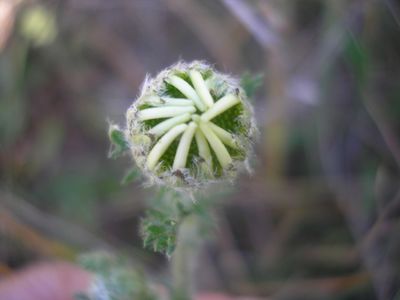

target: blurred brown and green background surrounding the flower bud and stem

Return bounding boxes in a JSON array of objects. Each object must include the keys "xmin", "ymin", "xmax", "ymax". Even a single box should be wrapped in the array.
[{"xmin": 0, "ymin": 0, "xmax": 400, "ymax": 300}]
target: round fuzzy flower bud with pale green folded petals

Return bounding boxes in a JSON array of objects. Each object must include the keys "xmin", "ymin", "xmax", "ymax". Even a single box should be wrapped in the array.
[{"xmin": 125, "ymin": 61, "xmax": 256, "ymax": 188}]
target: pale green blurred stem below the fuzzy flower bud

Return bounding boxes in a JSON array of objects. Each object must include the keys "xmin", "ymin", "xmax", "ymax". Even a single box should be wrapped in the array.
[{"xmin": 171, "ymin": 214, "xmax": 200, "ymax": 300}]
